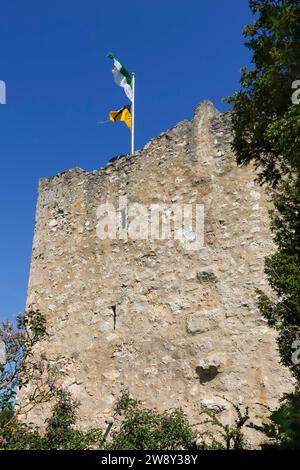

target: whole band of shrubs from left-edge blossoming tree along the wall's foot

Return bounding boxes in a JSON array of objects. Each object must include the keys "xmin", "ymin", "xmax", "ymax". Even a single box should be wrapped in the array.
[{"xmin": 0, "ymin": 312, "xmax": 251, "ymax": 450}]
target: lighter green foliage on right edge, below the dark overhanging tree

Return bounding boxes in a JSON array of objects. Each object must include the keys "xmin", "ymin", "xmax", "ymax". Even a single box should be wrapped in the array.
[{"xmin": 258, "ymin": 180, "xmax": 300, "ymax": 381}]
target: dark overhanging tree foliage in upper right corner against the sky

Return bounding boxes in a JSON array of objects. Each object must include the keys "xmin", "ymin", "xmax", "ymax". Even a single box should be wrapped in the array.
[{"xmin": 227, "ymin": 0, "xmax": 300, "ymax": 186}]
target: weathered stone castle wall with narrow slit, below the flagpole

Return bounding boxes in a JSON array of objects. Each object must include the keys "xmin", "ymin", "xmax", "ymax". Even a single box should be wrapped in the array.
[{"xmin": 24, "ymin": 102, "xmax": 291, "ymax": 444}]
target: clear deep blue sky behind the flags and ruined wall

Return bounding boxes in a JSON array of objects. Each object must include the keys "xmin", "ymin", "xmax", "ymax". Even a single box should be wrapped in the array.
[{"xmin": 0, "ymin": 0, "xmax": 252, "ymax": 319}]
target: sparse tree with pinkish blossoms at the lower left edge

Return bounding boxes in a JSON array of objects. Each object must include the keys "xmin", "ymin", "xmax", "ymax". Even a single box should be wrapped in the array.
[{"xmin": 0, "ymin": 311, "xmax": 58, "ymax": 449}]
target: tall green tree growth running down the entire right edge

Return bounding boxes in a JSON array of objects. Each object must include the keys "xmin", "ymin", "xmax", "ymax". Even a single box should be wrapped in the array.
[{"xmin": 228, "ymin": 0, "xmax": 300, "ymax": 448}]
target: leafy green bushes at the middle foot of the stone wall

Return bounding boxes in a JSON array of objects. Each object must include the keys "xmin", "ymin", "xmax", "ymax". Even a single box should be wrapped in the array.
[{"xmin": 105, "ymin": 391, "xmax": 249, "ymax": 450}]
